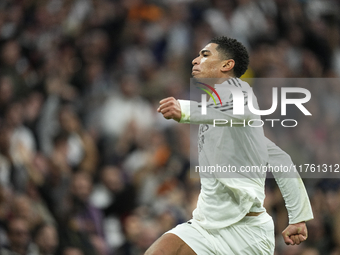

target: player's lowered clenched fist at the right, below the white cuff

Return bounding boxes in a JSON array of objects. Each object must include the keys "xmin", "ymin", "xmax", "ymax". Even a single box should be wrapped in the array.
[{"xmin": 282, "ymin": 222, "xmax": 308, "ymax": 245}]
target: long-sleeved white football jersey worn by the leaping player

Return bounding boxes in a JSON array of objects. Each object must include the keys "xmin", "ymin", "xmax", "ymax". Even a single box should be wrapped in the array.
[{"xmin": 178, "ymin": 78, "xmax": 313, "ymax": 229}]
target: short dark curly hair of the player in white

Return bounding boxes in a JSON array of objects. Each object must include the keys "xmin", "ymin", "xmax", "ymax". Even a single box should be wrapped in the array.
[{"xmin": 210, "ymin": 36, "xmax": 249, "ymax": 77}]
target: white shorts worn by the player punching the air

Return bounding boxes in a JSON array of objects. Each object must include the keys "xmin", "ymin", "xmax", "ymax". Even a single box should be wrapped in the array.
[{"xmin": 165, "ymin": 212, "xmax": 275, "ymax": 255}]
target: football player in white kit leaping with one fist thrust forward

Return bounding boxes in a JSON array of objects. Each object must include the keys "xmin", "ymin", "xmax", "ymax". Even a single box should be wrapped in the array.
[{"xmin": 145, "ymin": 37, "xmax": 313, "ymax": 255}]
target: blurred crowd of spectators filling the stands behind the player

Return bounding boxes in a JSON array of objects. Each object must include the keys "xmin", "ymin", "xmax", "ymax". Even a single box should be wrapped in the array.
[{"xmin": 0, "ymin": 0, "xmax": 340, "ymax": 255}]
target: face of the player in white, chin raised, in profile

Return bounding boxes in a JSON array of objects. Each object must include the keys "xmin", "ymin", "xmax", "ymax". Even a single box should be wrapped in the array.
[{"xmin": 191, "ymin": 43, "xmax": 223, "ymax": 78}]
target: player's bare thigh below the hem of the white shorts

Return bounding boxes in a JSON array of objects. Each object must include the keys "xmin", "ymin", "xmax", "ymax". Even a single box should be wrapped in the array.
[{"xmin": 145, "ymin": 233, "xmax": 196, "ymax": 255}]
